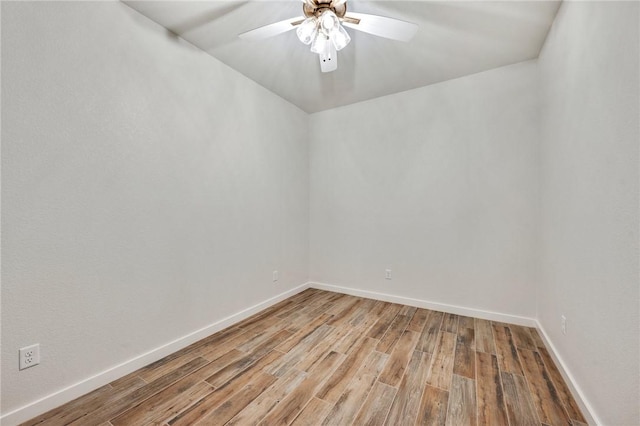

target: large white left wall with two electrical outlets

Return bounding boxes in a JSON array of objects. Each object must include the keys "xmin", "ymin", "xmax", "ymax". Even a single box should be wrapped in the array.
[{"xmin": 2, "ymin": 2, "xmax": 308, "ymax": 413}]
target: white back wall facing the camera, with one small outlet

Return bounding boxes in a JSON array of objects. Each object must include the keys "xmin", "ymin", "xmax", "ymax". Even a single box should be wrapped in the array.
[{"xmin": 310, "ymin": 62, "xmax": 538, "ymax": 317}]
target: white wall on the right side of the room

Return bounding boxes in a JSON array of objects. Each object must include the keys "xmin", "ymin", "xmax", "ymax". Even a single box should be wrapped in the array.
[{"xmin": 537, "ymin": 2, "xmax": 640, "ymax": 425}]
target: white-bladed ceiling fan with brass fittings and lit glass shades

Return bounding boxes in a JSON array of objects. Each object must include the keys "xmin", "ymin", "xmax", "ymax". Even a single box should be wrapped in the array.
[{"xmin": 239, "ymin": 0, "xmax": 418, "ymax": 72}]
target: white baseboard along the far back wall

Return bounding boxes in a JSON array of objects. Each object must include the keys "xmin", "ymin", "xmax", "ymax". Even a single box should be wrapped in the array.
[{"xmin": 309, "ymin": 282, "xmax": 538, "ymax": 327}]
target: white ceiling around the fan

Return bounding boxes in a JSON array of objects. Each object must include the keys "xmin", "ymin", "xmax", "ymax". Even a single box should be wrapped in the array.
[{"xmin": 125, "ymin": 0, "xmax": 560, "ymax": 113}]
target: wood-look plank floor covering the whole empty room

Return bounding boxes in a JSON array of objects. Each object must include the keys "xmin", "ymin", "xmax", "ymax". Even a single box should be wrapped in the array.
[{"xmin": 25, "ymin": 289, "xmax": 585, "ymax": 426}]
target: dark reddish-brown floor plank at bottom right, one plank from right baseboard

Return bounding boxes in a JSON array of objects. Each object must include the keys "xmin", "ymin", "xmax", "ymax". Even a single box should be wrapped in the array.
[{"xmin": 519, "ymin": 349, "xmax": 571, "ymax": 426}]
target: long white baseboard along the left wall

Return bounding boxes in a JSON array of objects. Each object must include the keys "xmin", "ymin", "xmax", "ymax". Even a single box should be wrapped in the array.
[{"xmin": 0, "ymin": 283, "xmax": 309, "ymax": 426}]
